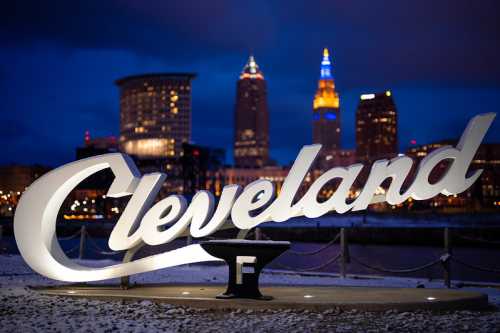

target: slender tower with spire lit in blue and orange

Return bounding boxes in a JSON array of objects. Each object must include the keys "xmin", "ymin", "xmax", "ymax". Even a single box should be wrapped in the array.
[{"xmin": 313, "ymin": 48, "xmax": 341, "ymax": 153}]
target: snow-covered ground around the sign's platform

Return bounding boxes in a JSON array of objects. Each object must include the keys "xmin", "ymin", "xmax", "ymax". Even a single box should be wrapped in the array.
[{"xmin": 0, "ymin": 255, "xmax": 500, "ymax": 332}]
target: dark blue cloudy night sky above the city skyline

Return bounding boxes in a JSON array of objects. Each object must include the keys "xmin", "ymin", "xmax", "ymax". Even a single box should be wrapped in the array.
[{"xmin": 0, "ymin": 0, "xmax": 500, "ymax": 166}]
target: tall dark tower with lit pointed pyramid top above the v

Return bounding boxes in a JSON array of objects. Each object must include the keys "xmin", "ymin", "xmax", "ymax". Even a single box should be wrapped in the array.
[{"xmin": 234, "ymin": 56, "xmax": 269, "ymax": 168}]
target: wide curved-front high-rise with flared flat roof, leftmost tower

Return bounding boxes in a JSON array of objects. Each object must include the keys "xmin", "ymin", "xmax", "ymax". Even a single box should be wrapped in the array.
[{"xmin": 116, "ymin": 73, "xmax": 195, "ymax": 159}]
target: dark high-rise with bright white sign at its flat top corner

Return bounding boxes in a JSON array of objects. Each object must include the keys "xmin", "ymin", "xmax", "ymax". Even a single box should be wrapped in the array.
[{"xmin": 356, "ymin": 90, "xmax": 398, "ymax": 162}]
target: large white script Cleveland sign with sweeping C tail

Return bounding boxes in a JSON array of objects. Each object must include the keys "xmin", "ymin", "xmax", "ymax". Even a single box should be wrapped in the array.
[{"xmin": 14, "ymin": 113, "xmax": 495, "ymax": 282}]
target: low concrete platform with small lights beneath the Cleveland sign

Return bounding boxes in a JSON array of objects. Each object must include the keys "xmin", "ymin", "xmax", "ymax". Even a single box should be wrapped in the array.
[{"xmin": 35, "ymin": 285, "xmax": 488, "ymax": 311}]
